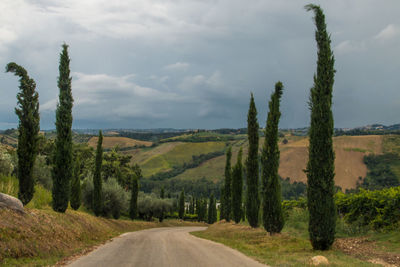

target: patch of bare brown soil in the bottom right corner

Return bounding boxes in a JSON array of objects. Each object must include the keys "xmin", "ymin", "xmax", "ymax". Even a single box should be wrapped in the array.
[{"xmin": 333, "ymin": 240, "xmax": 400, "ymax": 267}]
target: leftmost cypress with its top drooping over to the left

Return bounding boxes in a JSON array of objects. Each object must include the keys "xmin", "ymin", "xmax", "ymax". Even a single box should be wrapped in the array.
[{"xmin": 6, "ymin": 62, "xmax": 40, "ymax": 205}]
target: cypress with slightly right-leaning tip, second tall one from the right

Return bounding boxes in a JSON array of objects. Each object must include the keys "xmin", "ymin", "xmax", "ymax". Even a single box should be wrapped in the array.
[{"xmin": 261, "ymin": 82, "xmax": 284, "ymax": 234}]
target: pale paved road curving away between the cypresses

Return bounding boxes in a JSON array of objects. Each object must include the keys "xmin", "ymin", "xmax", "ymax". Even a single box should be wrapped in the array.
[{"xmin": 68, "ymin": 227, "xmax": 265, "ymax": 267}]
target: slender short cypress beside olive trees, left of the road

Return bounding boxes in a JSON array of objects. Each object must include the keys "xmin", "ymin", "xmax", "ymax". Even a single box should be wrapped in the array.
[{"xmin": 93, "ymin": 130, "xmax": 103, "ymax": 216}]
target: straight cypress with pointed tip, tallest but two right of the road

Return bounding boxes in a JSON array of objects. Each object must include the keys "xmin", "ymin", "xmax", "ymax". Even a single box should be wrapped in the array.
[{"xmin": 246, "ymin": 94, "xmax": 260, "ymax": 227}]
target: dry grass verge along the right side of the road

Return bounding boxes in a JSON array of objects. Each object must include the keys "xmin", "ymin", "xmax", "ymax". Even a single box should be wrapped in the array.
[{"xmin": 192, "ymin": 222, "xmax": 378, "ymax": 266}]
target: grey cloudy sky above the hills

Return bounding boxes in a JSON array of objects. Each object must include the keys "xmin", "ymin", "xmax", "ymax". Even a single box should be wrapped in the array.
[{"xmin": 0, "ymin": 0, "xmax": 400, "ymax": 129}]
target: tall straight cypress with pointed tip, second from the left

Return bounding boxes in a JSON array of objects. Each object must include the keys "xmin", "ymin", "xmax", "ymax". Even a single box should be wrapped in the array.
[{"xmin": 52, "ymin": 44, "xmax": 74, "ymax": 212}]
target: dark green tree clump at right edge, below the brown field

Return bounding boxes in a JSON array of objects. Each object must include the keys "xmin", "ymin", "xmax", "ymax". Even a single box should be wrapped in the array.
[{"xmin": 359, "ymin": 153, "xmax": 400, "ymax": 190}]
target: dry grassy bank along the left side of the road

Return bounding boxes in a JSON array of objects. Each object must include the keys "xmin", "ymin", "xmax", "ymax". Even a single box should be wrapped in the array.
[{"xmin": 0, "ymin": 209, "xmax": 203, "ymax": 266}]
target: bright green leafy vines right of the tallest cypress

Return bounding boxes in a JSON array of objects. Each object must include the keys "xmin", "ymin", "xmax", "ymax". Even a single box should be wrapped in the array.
[{"xmin": 335, "ymin": 187, "xmax": 400, "ymax": 229}]
